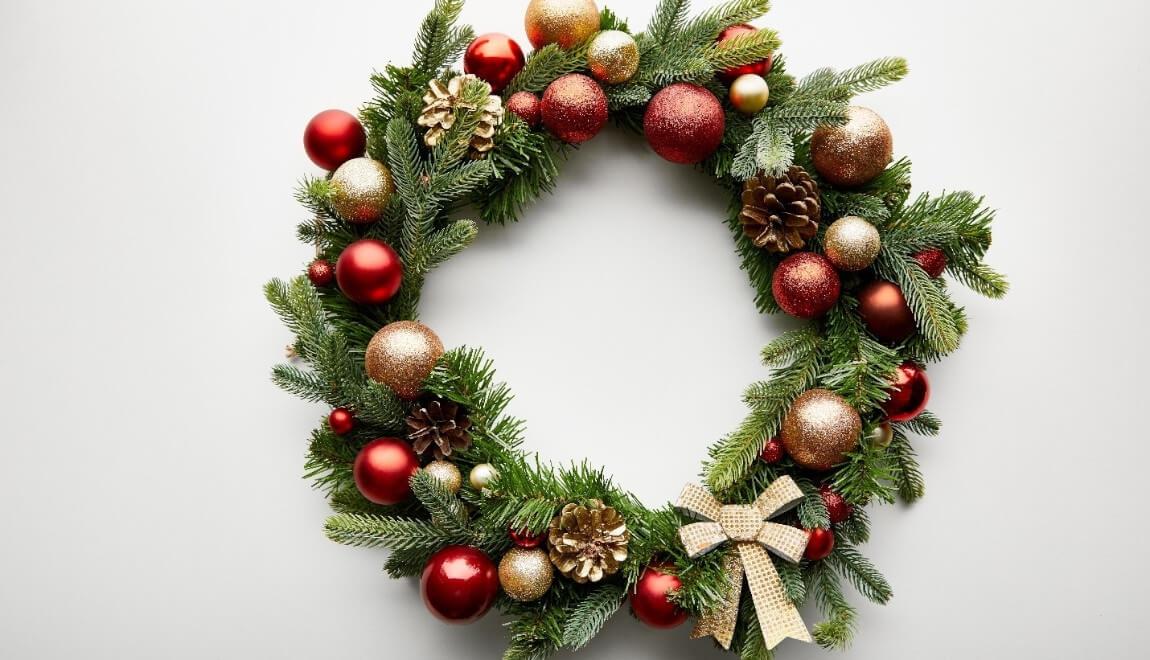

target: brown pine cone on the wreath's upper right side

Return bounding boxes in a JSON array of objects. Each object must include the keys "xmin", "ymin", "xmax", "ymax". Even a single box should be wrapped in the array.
[{"xmin": 738, "ymin": 166, "xmax": 822, "ymax": 253}]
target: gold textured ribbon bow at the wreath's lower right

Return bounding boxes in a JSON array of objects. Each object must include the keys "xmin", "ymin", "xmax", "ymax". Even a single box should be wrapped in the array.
[{"xmin": 676, "ymin": 476, "xmax": 811, "ymax": 650}]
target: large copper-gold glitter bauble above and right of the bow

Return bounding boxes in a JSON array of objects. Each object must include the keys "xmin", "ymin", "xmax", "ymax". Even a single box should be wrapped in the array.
[{"xmin": 780, "ymin": 390, "xmax": 863, "ymax": 470}]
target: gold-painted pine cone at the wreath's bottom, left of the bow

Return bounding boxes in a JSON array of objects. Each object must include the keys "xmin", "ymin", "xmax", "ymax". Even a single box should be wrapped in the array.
[{"xmin": 547, "ymin": 500, "xmax": 631, "ymax": 584}]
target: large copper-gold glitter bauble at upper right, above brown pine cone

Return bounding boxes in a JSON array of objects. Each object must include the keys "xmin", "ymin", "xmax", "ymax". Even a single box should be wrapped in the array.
[{"xmin": 811, "ymin": 106, "xmax": 895, "ymax": 187}]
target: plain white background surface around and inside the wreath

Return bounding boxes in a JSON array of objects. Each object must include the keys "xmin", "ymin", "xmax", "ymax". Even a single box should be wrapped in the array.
[{"xmin": 0, "ymin": 0, "xmax": 1150, "ymax": 660}]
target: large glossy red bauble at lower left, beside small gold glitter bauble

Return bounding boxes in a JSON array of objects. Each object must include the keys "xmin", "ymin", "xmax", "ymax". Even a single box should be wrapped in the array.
[{"xmin": 420, "ymin": 545, "xmax": 499, "ymax": 623}]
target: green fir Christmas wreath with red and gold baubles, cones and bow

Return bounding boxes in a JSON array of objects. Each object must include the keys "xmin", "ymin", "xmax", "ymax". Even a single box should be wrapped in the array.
[{"xmin": 266, "ymin": 0, "xmax": 1006, "ymax": 659}]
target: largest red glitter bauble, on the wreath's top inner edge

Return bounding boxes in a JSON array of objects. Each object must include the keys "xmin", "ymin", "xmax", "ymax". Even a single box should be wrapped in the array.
[{"xmin": 643, "ymin": 83, "xmax": 727, "ymax": 164}]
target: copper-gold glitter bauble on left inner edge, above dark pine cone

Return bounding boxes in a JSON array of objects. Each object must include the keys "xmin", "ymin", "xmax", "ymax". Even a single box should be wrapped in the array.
[{"xmin": 363, "ymin": 321, "xmax": 443, "ymax": 400}]
